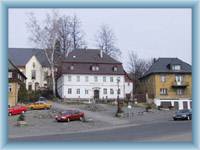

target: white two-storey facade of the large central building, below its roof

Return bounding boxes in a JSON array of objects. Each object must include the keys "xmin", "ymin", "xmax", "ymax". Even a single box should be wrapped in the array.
[{"xmin": 57, "ymin": 74, "xmax": 132, "ymax": 99}]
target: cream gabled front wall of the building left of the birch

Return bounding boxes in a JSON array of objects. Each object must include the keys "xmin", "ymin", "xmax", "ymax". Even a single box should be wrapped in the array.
[{"xmin": 20, "ymin": 55, "xmax": 50, "ymax": 90}]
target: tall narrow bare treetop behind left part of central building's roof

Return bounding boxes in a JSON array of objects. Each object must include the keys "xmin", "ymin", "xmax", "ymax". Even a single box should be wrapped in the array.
[{"xmin": 70, "ymin": 15, "xmax": 86, "ymax": 49}]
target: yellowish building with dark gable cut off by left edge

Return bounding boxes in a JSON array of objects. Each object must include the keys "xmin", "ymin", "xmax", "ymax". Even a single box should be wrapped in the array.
[{"xmin": 8, "ymin": 60, "xmax": 26, "ymax": 107}]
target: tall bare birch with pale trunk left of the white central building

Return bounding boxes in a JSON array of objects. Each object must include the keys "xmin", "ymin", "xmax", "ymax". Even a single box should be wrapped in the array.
[{"xmin": 27, "ymin": 12, "xmax": 59, "ymax": 96}]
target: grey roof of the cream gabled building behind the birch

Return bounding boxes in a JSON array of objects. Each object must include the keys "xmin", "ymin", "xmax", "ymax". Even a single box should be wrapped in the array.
[{"xmin": 8, "ymin": 48, "xmax": 49, "ymax": 67}]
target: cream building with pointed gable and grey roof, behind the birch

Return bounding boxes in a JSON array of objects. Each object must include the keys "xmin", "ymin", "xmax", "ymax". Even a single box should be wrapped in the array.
[{"xmin": 9, "ymin": 48, "xmax": 50, "ymax": 90}]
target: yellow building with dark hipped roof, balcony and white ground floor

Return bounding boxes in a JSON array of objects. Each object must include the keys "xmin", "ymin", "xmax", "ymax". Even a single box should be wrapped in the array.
[{"xmin": 140, "ymin": 58, "xmax": 192, "ymax": 109}]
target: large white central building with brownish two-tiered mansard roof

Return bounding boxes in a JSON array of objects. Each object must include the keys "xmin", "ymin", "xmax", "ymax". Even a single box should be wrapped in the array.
[{"xmin": 57, "ymin": 49, "xmax": 133, "ymax": 100}]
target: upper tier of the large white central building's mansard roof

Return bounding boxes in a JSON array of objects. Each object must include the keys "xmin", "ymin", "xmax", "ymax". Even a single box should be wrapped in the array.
[{"xmin": 65, "ymin": 49, "xmax": 121, "ymax": 64}]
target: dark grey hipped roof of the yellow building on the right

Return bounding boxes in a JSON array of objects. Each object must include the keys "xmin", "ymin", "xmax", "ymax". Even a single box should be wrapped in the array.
[{"xmin": 142, "ymin": 58, "xmax": 192, "ymax": 78}]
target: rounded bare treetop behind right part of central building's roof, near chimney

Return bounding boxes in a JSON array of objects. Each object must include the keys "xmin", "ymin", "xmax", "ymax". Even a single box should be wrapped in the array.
[{"xmin": 95, "ymin": 25, "xmax": 121, "ymax": 58}]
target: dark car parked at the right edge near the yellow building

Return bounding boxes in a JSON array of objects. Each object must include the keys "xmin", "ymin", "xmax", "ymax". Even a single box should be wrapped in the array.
[{"xmin": 173, "ymin": 109, "xmax": 192, "ymax": 120}]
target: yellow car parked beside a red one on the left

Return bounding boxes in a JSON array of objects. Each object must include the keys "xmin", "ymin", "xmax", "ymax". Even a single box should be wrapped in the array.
[{"xmin": 27, "ymin": 101, "xmax": 52, "ymax": 110}]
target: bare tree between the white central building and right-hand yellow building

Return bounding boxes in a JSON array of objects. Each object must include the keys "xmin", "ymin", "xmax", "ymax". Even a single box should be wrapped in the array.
[{"xmin": 128, "ymin": 51, "xmax": 153, "ymax": 94}]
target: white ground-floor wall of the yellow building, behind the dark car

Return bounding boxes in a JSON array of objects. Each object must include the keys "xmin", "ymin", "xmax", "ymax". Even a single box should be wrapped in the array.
[{"xmin": 154, "ymin": 99, "xmax": 192, "ymax": 109}]
